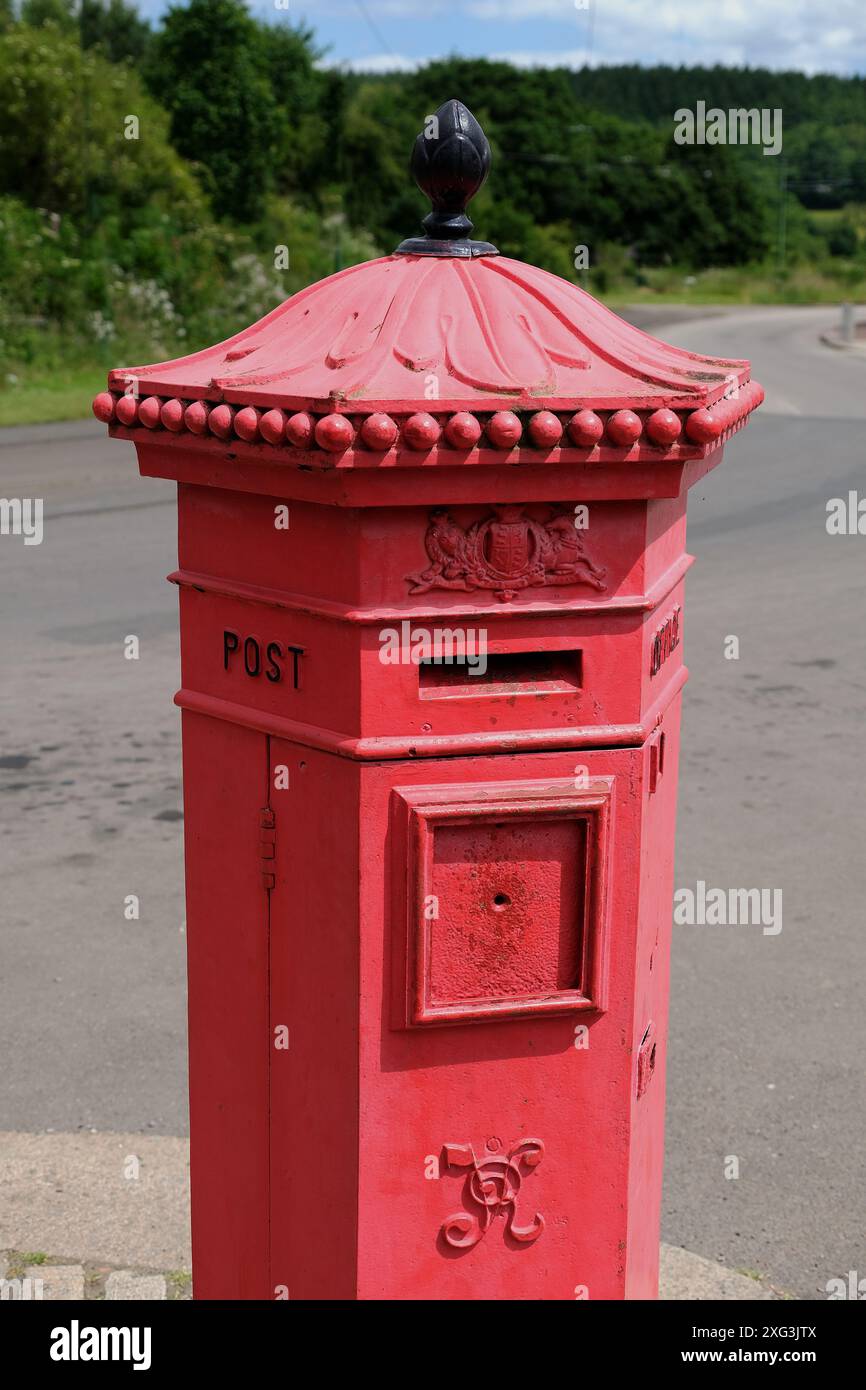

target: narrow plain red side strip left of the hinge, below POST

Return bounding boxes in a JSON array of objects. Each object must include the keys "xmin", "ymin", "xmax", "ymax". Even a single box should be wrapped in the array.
[{"xmin": 183, "ymin": 712, "xmax": 271, "ymax": 1298}]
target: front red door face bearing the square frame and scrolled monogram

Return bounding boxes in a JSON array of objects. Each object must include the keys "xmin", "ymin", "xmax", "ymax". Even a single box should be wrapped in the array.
[{"xmin": 359, "ymin": 748, "xmax": 646, "ymax": 1301}]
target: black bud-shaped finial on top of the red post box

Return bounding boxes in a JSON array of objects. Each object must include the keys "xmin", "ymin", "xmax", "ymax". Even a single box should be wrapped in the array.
[{"xmin": 396, "ymin": 101, "xmax": 499, "ymax": 256}]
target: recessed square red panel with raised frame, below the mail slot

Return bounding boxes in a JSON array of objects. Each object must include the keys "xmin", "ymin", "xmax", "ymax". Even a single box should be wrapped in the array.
[{"xmin": 393, "ymin": 777, "xmax": 613, "ymax": 1027}]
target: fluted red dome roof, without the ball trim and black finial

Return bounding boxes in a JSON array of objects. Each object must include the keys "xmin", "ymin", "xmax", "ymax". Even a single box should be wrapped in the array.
[{"xmin": 110, "ymin": 254, "xmax": 749, "ymax": 414}]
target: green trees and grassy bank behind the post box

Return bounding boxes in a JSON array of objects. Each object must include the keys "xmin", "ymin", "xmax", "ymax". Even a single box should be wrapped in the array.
[{"xmin": 0, "ymin": 0, "xmax": 866, "ymax": 420}]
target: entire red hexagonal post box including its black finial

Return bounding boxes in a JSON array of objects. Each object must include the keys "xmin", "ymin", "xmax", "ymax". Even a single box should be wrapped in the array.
[{"xmin": 95, "ymin": 101, "xmax": 762, "ymax": 1300}]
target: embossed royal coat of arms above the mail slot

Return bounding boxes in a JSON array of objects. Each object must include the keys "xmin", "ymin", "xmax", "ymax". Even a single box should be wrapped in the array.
[{"xmin": 406, "ymin": 505, "xmax": 607, "ymax": 602}]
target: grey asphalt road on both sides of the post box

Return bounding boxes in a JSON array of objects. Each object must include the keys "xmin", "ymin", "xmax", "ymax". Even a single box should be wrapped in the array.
[{"xmin": 0, "ymin": 309, "xmax": 866, "ymax": 1298}]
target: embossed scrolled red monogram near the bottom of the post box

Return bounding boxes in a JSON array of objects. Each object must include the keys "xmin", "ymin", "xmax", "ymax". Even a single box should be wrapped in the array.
[{"xmin": 442, "ymin": 1138, "xmax": 545, "ymax": 1250}]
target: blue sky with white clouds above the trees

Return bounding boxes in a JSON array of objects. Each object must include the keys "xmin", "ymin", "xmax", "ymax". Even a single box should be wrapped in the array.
[{"xmin": 140, "ymin": 0, "xmax": 866, "ymax": 75}]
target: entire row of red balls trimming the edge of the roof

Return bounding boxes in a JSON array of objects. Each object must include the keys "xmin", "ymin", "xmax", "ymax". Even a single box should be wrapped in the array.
[{"xmin": 93, "ymin": 381, "xmax": 763, "ymax": 455}]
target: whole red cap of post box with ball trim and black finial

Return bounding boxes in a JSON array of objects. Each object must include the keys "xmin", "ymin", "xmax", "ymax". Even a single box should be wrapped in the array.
[{"xmin": 95, "ymin": 101, "xmax": 763, "ymax": 459}]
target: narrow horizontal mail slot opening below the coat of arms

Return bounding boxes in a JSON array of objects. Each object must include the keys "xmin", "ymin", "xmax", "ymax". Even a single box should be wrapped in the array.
[{"xmin": 418, "ymin": 651, "xmax": 582, "ymax": 699}]
